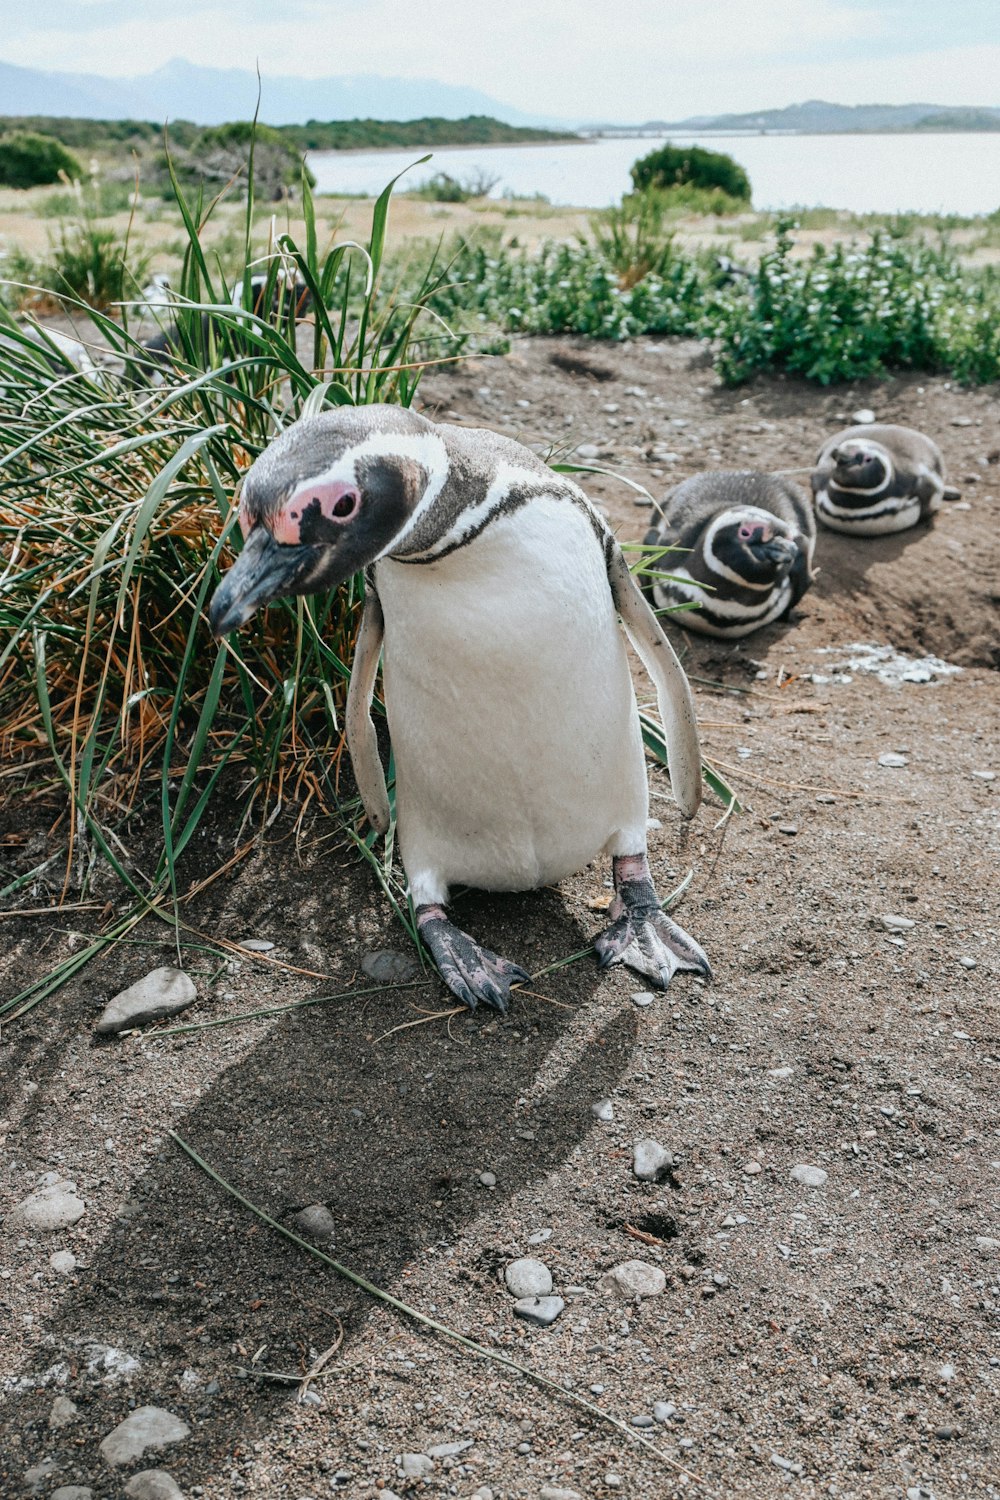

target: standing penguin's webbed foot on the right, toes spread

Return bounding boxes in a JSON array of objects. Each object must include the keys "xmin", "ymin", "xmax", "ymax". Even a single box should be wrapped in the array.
[{"xmin": 594, "ymin": 855, "xmax": 712, "ymax": 990}]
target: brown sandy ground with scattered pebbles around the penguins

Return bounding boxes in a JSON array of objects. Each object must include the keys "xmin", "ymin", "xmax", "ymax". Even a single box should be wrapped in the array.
[{"xmin": 0, "ymin": 341, "xmax": 1000, "ymax": 1500}]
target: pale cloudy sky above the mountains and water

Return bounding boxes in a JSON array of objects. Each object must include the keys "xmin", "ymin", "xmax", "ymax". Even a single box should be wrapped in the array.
[{"xmin": 0, "ymin": 0, "xmax": 1000, "ymax": 122}]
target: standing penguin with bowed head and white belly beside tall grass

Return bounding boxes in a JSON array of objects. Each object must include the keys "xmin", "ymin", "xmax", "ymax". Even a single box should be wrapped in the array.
[{"xmin": 210, "ymin": 407, "xmax": 711, "ymax": 1011}]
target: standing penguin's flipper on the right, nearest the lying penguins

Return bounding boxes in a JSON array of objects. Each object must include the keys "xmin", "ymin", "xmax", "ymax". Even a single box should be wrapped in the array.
[{"xmin": 607, "ymin": 539, "xmax": 702, "ymax": 818}]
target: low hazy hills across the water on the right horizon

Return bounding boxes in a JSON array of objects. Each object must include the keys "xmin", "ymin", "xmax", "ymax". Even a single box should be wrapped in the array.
[{"xmin": 594, "ymin": 99, "xmax": 1000, "ymax": 135}]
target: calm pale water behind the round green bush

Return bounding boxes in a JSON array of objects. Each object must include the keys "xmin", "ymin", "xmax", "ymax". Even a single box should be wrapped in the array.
[{"xmin": 309, "ymin": 134, "xmax": 1000, "ymax": 215}]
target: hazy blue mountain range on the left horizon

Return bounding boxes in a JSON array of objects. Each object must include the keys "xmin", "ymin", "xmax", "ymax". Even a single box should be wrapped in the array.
[{"xmin": 0, "ymin": 59, "xmax": 567, "ymax": 129}]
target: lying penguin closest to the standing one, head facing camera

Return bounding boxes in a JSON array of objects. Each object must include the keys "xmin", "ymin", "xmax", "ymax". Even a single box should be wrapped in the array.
[{"xmin": 645, "ymin": 470, "xmax": 816, "ymax": 639}]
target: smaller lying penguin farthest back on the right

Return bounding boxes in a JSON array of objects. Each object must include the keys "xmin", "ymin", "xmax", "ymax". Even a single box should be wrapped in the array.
[{"xmin": 813, "ymin": 425, "xmax": 960, "ymax": 537}]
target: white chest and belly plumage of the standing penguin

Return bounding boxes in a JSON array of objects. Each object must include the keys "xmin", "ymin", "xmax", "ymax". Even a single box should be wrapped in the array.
[{"xmin": 376, "ymin": 498, "xmax": 646, "ymax": 900}]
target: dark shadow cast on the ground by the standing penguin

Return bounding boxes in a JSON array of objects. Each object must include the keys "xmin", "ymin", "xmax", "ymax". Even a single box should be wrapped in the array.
[{"xmin": 0, "ymin": 869, "xmax": 636, "ymax": 1497}]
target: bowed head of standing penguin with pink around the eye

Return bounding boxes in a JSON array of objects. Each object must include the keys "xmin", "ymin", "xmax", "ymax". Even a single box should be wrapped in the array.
[{"xmin": 208, "ymin": 407, "xmax": 448, "ymax": 636}]
